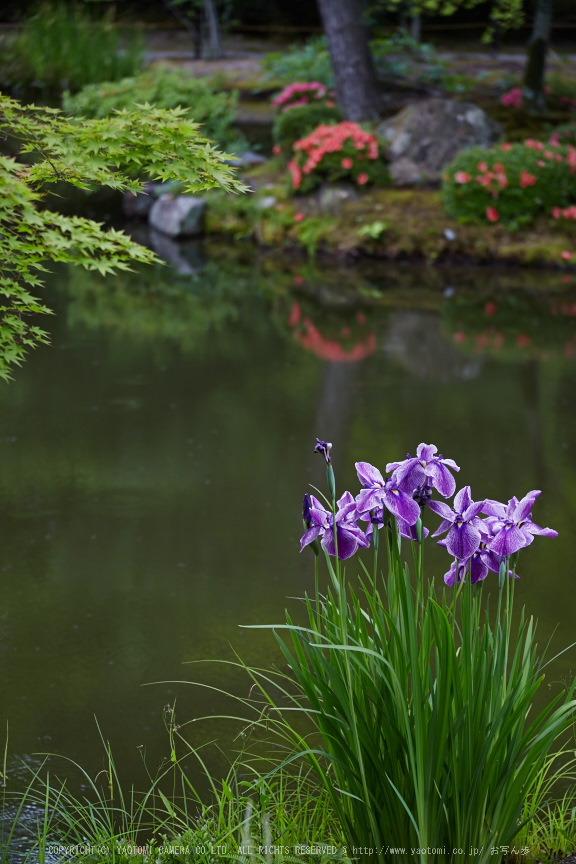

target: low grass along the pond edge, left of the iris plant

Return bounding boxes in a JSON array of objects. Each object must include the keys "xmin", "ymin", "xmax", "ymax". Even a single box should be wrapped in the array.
[{"xmin": 0, "ymin": 706, "xmax": 352, "ymax": 864}]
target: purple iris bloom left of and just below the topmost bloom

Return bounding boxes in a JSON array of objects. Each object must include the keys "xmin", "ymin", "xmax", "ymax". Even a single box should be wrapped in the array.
[{"xmin": 356, "ymin": 462, "xmax": 426, "ymax": 525}]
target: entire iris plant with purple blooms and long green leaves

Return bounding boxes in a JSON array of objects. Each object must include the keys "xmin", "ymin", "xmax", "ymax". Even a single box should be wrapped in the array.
[{"xmin": 249, "ymin": 441, "xmax": 576, "ymax": 864}]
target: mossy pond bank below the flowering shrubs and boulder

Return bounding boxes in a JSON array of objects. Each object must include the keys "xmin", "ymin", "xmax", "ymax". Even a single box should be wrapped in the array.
[{"xmin": 206, "ymin": 169, "xmax": 576, "ymax": 272}]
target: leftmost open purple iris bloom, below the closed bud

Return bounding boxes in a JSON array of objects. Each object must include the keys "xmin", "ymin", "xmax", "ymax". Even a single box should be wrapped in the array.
[{"xmin": 300, "ymin": 492, "xmax": 370, "ymax": 558}]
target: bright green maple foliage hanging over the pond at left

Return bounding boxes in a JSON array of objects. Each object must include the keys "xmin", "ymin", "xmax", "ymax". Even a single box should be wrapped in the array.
[{"xmin": 0, "ymin": 93, "xmax": 246, "ymax": 379}]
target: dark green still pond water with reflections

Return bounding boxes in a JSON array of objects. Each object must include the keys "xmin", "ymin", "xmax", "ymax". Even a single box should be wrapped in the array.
[{"xmin": 0, "ymin": 241, "xmax": 576, "ymax": 804}]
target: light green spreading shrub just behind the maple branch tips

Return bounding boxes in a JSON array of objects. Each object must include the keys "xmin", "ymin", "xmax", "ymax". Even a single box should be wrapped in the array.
[{"xmin": 62, "ymin": 67, "xmax": 246, "ymax": 150}]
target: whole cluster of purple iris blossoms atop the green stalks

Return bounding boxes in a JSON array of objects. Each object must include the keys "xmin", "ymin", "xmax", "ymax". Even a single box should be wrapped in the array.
[{"xmin": 300, "ymin": 438, "xmax": 558, "ymax": 585}]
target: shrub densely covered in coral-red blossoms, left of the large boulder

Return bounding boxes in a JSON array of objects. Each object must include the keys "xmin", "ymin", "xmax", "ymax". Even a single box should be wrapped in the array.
[{"xmin": 288, "ymin": 121, "xmax": 387, "ymax": 192}]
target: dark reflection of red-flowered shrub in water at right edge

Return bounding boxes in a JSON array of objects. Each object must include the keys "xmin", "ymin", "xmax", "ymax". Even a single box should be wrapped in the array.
[{"xmin": 442, "ymin": 294, "xmax": 576, "ymax": 361}]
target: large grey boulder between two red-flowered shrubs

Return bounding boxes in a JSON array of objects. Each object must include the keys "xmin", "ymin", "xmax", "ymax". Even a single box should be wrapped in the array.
[{"xmin": 376, "ymin": 99, "xmax": 502, "ymax": 186}]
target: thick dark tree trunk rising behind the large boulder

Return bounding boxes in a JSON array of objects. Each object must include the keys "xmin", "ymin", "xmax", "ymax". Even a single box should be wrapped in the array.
[{"xmin": 318, "ymin": 0, "xmax": 381, "ymax": 122}]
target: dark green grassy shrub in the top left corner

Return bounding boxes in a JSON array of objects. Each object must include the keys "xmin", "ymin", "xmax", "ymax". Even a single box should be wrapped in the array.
[{"xmin": 13, "ymin": 2, "xmax": 143, "ymax": 91}]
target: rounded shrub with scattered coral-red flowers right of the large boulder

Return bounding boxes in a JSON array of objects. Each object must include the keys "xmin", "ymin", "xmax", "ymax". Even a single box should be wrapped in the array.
[{"xmin": 442, "ymin": 139, "xmax": 576, "ymax": 228}]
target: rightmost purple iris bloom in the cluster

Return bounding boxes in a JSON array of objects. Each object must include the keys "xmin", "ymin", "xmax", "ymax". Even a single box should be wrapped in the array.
[{"xmin": 482, "ymin": 489, "xmax": 558, "ymax": 557}]
